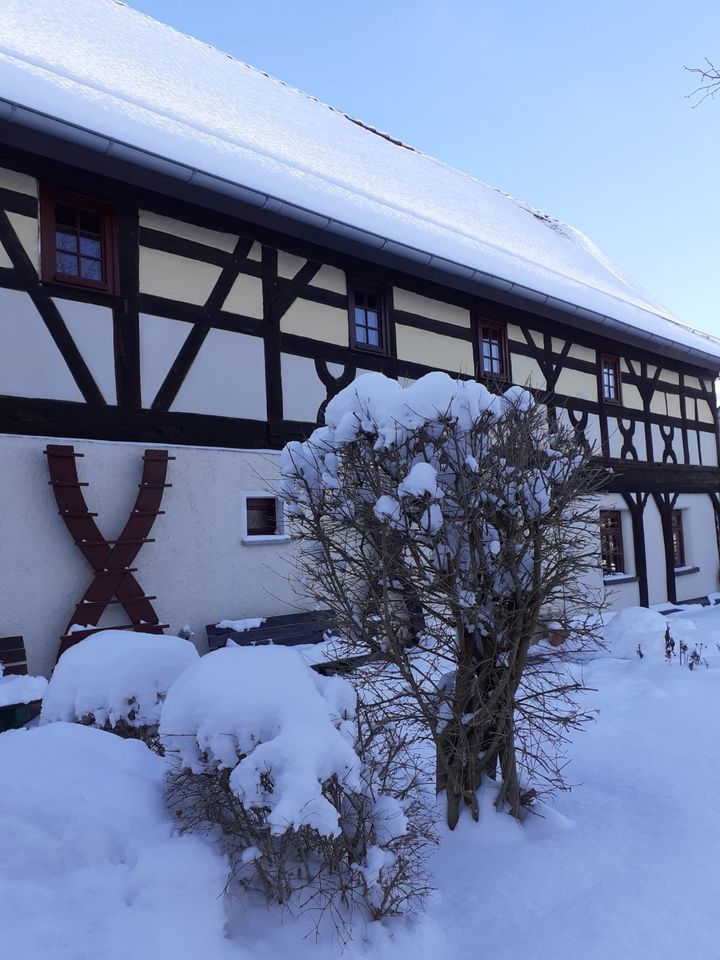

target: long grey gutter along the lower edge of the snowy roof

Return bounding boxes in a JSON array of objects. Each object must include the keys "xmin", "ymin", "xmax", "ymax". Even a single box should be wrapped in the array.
[{"xmin": 0, "ymin": 97, "xmax": 720, "ymax": 371}]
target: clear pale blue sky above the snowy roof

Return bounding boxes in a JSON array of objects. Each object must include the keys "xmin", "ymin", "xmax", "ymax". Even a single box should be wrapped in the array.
[{"xmin": 131, "ymin": 0, "xmax": 720, "ymax": 336}]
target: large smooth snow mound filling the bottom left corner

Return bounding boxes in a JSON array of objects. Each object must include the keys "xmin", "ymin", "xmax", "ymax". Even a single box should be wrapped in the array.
[{"xmin": 0, "ymin": 723, "xmax": 236, "ymax": 960}]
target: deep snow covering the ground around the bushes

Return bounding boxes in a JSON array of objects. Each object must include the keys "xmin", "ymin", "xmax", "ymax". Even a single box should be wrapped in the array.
[{"xmin": 0, "ymin": 608, "xmax": 720, "ymax": 960}]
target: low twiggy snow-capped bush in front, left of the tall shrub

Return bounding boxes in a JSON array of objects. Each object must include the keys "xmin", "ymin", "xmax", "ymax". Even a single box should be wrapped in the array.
[{"xmin": 160, "ymin": 646, "xmax": 424, "ymax": 919}]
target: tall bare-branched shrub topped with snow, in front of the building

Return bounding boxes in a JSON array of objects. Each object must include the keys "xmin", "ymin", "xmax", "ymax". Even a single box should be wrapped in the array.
[{"xmin": 281, "ymin": 372, "xmax": 603, "ymax": 826}]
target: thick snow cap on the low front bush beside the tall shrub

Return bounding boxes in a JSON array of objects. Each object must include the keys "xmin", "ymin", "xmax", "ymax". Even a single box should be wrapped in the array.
[{"xmin": 160, "ymin": 646, "xmax": 359, "ymax": 836}]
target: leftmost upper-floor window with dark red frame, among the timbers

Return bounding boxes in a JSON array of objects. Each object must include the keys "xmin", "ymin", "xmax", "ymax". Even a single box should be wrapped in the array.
[{"xmin": 40, "ymin": 189, "xmax": 116, "ymax": 293}]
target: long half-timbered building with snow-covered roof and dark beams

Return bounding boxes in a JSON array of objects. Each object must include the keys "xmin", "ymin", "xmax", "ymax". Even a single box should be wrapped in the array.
[{"xmin": 0, "ymin": 0, "xmax": 720, "ymax": 670}]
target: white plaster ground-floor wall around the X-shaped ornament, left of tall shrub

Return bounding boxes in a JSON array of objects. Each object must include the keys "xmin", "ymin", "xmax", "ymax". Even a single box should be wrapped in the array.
[{"xmin": 0, "ymin": 435, "xmax": 300, "ymax": 672}]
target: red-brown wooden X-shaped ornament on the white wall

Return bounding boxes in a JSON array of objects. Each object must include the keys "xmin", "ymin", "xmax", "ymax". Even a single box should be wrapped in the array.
[{"xmin": 45, "ymin": 444, "xmax": 175, "ymax": 656}]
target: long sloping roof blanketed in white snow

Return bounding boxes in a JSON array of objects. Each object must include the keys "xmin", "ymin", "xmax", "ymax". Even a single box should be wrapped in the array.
[{"xmin": 0, "ymin": 0, "xmax": 720, "ymax": 368}]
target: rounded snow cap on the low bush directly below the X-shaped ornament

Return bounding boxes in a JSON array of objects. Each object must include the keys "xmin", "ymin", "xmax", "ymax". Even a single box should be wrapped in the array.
[{"xmin": 40, "ymin": 630, "xmax": 199, "ymax": 732}]
